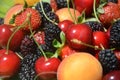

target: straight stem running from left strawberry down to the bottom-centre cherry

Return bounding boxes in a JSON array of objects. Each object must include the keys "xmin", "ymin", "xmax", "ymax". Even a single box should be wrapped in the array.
[{"xmin": 28, "ymin": 14, "xmax": 48, "ymax": 60}]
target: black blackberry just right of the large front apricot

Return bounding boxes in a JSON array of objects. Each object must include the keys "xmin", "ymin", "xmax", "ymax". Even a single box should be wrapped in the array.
[{"xmin": 99, "ymin": 49, "xmax": 119, "ymax": 74}]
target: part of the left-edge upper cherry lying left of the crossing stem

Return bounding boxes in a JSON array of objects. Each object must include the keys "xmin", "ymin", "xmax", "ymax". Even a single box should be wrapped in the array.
[{"xmin": 0, "ymin": 24, "xmax": 12, "ymax": 48}]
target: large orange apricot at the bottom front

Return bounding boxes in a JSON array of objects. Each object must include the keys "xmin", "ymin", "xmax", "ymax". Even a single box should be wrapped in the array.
[{"xmin": 57, "ymin": 52, "xmax": 103, "ymax": 80}]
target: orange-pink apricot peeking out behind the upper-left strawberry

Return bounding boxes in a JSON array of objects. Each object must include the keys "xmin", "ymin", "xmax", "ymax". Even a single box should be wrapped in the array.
[{"xmin": 4, "ymin": 4, "xmax": 23, "ymax": 24}]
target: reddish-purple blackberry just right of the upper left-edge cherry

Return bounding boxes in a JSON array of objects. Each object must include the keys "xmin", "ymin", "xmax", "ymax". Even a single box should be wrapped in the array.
[{"xmin": 20, "ymin": 35, "xmax": 37, "ymax": 56}]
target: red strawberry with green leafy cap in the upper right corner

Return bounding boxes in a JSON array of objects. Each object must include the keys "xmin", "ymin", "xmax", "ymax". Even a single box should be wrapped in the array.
[{"xmin": 99, "ymin": 2, "xmax": 120, "ymax": 28}]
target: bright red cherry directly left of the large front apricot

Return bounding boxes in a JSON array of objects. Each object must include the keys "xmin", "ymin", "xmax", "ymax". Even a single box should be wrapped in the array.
[{"xmin": 35, "ymin": 57, "xmax": 60, "ymax": 80}]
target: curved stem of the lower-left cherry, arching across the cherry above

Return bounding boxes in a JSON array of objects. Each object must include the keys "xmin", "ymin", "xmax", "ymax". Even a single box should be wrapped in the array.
[{"xmin": 6, "ymin": 12, "xmax": 29, "ymax": 54}]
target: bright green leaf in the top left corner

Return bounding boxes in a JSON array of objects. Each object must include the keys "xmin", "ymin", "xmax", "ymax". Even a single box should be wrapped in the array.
[{"xmin": 0, "ymin": 0, "xmax": 14, "ymax": 18}]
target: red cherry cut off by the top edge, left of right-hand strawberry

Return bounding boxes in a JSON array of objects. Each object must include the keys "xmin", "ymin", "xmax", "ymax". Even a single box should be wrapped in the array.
[{"xmin": 74, "ymin": 0, "xmax": 99, "ymax": 16}]
